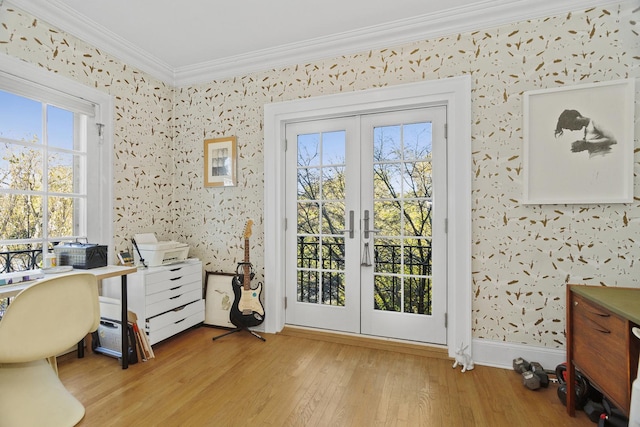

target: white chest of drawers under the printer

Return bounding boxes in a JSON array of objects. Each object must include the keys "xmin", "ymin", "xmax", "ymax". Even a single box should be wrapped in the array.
[{"xmin": 102, "ymin": 260, "xmax": 205, "ymax": 345}]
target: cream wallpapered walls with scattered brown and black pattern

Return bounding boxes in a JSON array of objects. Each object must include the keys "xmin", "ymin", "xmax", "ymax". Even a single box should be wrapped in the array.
[{"xmin": 0, "ymin": 2, "xmax": 640, "ymax": 348}]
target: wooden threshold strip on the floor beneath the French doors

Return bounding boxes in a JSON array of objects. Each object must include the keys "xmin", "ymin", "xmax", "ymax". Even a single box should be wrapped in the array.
[{"xmin": 279, "ymin": 325, "xmax": 451, "ymax": 360}]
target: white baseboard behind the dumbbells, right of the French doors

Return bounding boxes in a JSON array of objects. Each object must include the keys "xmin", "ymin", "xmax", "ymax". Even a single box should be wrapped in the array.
[{"xmin": 472, "ymin": 339, "xmax": 566, "ymax": 370}]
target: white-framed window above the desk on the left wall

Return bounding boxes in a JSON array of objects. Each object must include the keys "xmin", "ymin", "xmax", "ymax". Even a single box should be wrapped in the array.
[{"xmin": 0, "ymin": 51, "xmax": 113, "ymax": 272}]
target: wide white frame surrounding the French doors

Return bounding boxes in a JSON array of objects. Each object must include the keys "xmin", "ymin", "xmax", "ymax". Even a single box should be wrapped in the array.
[{"xmin": 264, "ymin": 75, "xmax": 473, "ymax": 357}]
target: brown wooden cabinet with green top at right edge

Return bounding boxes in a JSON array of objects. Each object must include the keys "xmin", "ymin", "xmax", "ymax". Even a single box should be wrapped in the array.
[{"xmin": 567, "ymin": 285, "xmax": 640, "ymax": 416}]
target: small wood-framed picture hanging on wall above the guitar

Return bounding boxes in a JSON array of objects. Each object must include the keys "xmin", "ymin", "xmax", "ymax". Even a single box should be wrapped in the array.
[{"xmin": 204, "ymin": 136, "xmax": 236, "ymax": 187}]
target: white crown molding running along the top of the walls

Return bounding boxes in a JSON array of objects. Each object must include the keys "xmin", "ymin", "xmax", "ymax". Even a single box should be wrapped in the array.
[{"xmin": 7, "ymin": 0, "xmax": 634, "ymax": 87}]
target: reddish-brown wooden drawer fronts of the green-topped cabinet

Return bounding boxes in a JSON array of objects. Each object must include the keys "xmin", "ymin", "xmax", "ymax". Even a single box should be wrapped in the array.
[{"xmin": 572, "ymin": 295, "xmax": 630, "ymax": 408}]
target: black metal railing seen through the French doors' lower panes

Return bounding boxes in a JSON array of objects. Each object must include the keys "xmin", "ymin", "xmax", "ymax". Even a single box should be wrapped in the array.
[{"xmin": 298, "ymin": 236, "xmax": 432, "ymax": 314}]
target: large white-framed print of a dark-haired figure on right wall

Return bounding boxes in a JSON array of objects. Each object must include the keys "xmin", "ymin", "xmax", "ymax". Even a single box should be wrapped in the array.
[{"xmin": 523, "ymin": 79, "xmax": 635, "ymax": 204}]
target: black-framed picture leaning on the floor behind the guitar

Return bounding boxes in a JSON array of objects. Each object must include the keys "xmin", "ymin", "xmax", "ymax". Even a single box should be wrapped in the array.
[{"xmin": 204, "ymin": 271, "xmax": 235, "ymax": 328}]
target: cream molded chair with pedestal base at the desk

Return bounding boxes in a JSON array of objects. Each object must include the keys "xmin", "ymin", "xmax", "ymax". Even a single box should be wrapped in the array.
[{"xmin": 0, "ymin": 273, "xmax": 100, "ymax": 427}]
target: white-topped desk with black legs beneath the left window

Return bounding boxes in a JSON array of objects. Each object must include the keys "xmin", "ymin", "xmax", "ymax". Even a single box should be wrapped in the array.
[{"xmin": 0, "ymin": 265, "xmax": 138, "ymax": 369}]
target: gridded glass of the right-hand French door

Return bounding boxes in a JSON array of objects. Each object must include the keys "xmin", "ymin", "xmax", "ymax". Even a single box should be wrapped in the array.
[{"xmin": 373, "ymin": 122, "xmax": 433, "ymax": 314}]
